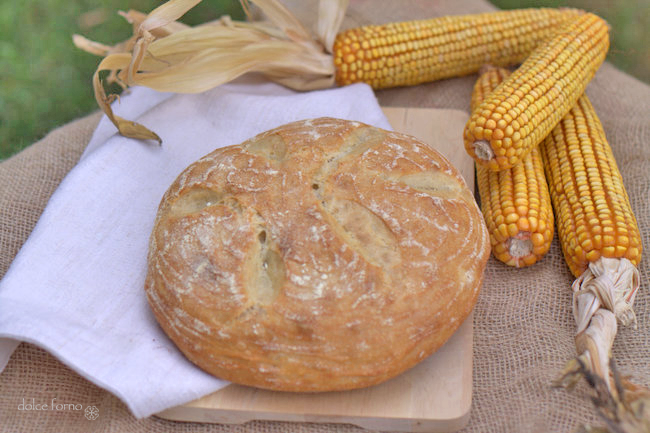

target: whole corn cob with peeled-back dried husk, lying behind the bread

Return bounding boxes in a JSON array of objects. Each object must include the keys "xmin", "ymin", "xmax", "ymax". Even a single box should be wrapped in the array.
[{"xmin": 73, "ymin": 0, "xmax": 584, "ymax": 141}]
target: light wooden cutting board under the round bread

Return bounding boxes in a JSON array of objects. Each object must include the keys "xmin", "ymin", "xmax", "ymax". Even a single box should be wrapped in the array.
[{"xmin": 157, "ymin": 107, "xmax": 474, "ymax": 432}]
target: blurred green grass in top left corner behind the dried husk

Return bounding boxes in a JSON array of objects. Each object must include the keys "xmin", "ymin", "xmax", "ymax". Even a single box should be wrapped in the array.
[{"xmin": 0, "ymin": 0, "xmax": 243, "ymax": 160}]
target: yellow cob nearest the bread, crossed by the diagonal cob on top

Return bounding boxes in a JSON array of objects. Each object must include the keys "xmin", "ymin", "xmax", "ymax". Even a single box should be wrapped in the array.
[{"xmin": 471, "ymin": 67, "xmax": 554, "ymax": 268}]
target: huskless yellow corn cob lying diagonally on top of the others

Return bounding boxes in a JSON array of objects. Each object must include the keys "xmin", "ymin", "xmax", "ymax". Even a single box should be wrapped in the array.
[{"xmin": 464, "ymin": 13, "xmax": 609, "ymax": 170}]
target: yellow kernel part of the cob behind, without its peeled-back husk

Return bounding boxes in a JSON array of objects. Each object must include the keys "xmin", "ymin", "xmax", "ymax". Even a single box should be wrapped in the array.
[{"xmin": 333, "ymin": 8, "xmax": 583, "ymax": 89}]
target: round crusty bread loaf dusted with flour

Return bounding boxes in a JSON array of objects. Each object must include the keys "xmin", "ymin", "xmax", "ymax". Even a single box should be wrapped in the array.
[{"xmin": 146, "ymin": 118, "xmax": 490, "ymax": 391}]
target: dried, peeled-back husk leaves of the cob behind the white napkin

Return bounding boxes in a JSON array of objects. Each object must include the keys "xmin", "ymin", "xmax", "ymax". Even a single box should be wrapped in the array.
[{"xmin": 73, "ymin": 0, "xmax": 348, "ymax": 142}]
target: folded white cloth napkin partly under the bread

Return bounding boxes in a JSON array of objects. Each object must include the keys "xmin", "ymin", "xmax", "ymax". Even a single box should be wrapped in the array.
[{"xmin": 0, "ymin": 80, "xmax": 390, "ymax": 418}]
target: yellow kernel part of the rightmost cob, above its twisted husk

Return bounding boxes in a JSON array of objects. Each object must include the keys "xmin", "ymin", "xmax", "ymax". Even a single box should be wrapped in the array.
[{"xmin": 540, "ymin": 95, "xmax": 641, "ymax": 277}]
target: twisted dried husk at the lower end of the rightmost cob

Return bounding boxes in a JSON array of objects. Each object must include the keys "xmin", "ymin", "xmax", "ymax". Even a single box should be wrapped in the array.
[{"xmin": 555, "ymin": 258, "xmax": 650, "ymax": 433}]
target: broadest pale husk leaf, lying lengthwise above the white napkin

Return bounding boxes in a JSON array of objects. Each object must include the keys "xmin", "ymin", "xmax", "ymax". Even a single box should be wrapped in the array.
[{"xmin": 100, "ymin": 26, "xmax": 332, "ymax": 93}]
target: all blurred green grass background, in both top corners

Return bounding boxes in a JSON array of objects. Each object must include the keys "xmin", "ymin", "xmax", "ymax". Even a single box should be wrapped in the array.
[{"xmin": 0, "ymin": 0, "xmax": 650, "ymax": 160}]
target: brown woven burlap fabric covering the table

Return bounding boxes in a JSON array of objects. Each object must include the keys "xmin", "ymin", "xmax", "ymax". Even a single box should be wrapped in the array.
[{"xmin": 0, "ymin": 0, "xmax": 650, "ymax": 433}]
